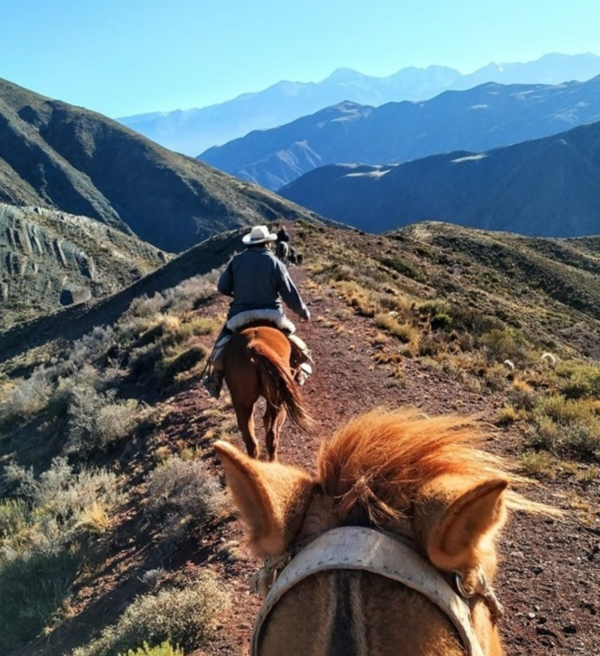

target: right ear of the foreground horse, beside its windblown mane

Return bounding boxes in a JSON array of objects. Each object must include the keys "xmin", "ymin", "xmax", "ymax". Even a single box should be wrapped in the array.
[{"xmin": 416, "ymin": 476, "xmax": 508, "ymax": 572}]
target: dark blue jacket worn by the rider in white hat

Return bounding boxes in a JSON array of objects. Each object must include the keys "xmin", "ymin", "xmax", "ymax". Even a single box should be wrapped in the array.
[{"xmin": 217, "ymin": 245, "xmax": 310, "ymax": 319}]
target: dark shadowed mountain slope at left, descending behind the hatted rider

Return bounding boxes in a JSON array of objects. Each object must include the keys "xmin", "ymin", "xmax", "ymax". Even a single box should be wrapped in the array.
[{"xmin": 0, "ymin": 80, "xmax": 318, "ymax": 252}]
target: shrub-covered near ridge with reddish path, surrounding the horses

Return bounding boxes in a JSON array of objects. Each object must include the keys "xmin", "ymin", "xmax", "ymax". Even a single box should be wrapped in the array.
[{"xmin": 0, "ymin": 221, "xmax": 600, "ymax": 656}]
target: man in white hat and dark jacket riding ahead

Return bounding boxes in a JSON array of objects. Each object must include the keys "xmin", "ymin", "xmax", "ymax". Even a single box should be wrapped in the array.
[{"xmin": 203, "ymin": 225, "xmax": 312, "ymax": 398}]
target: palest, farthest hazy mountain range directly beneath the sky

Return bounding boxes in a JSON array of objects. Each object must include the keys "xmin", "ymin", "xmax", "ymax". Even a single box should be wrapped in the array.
[{"xmin": 117, "ymin": 53, "xmax": 600, "ymax": 156}]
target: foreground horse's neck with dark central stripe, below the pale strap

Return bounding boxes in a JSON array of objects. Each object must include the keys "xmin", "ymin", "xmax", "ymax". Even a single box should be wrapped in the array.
[{"xmin": 258, "ymin": 570, "xmax": 478, "ymax": 656}]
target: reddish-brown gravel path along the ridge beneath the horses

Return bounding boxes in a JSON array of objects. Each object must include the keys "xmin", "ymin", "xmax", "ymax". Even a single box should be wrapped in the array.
[{"xmin": 179, "ymin": 269, "xmax": 600, "ymax": 656}]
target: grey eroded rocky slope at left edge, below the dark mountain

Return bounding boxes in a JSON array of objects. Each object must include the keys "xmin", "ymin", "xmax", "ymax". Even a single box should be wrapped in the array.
[{"xmin": 0, "ymin": 203, "xmax": 169, "ymax": 330}]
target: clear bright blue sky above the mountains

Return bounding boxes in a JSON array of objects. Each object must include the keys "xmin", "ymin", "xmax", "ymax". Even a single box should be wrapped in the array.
[{"xmin": 0, "ymin": 0, "xmax": 600, "ymax": 117}]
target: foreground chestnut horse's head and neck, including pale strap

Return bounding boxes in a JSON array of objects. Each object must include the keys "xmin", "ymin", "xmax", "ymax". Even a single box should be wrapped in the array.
[{"xmin": 215, "ymin": 410, "xmax": 556, "ymax": 656}]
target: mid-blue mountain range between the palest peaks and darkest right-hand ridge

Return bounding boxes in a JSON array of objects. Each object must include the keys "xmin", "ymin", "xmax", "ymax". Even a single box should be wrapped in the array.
[{"xmin": 200, "ymin": 76, "xmax": 600, "ymax": 189}]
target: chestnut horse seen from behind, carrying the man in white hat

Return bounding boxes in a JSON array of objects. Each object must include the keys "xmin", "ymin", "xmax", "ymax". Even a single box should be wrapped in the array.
[{"xmin": 223, "ymin": 326, "xmax": 312, "ymax": 460}]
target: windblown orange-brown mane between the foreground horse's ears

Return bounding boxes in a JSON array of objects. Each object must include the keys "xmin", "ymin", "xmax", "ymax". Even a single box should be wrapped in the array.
[{"xmin": 317, "ymin": 408, "xmax": 559, "ymax": 524}]
